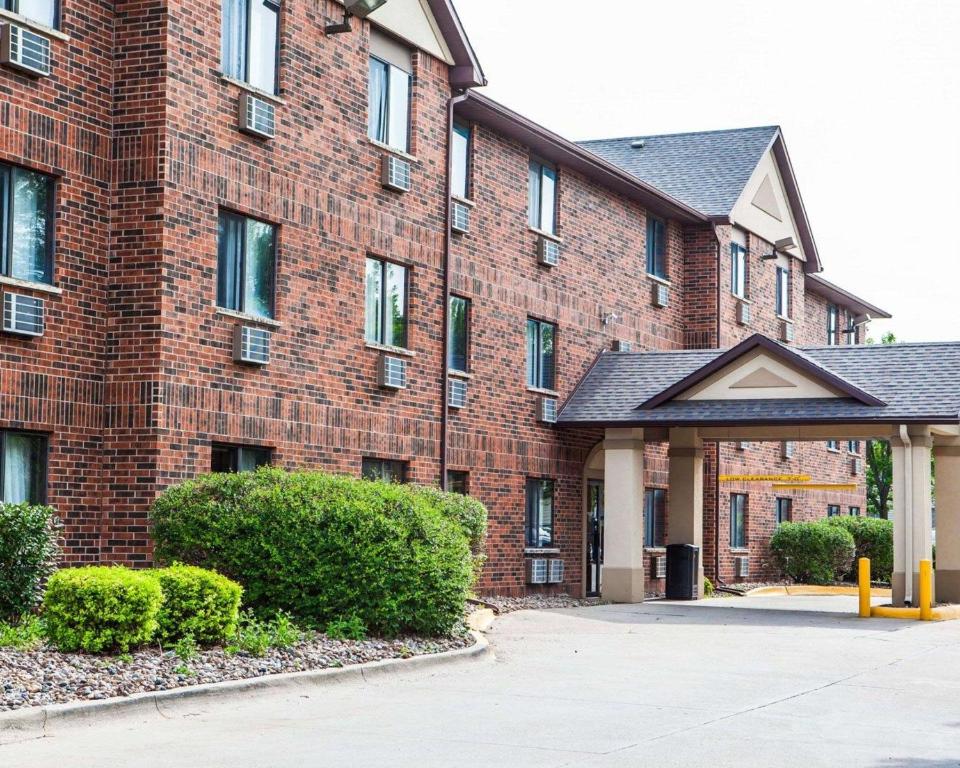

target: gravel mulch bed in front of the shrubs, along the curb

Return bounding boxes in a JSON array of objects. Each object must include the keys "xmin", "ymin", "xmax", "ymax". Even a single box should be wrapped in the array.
[{"xmin": 0, "ymin": 633, "xmax": 473, "ymax": 712}]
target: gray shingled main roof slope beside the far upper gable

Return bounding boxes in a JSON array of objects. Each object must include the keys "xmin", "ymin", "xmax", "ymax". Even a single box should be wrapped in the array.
[{"xmin": 577, "ymin": 125, "xmax": 780, "ymax": 216}]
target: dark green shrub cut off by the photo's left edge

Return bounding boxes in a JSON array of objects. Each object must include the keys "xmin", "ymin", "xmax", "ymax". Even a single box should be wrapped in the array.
[{"xmin": 0, "ymin": 503, "xmax": 62, "ymax": 621}]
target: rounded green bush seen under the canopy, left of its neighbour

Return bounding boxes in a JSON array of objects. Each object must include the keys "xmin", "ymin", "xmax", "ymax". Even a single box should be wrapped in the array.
[{"xmin": 770, "ymin": 520, "xmax": 854, "ymax": 584}]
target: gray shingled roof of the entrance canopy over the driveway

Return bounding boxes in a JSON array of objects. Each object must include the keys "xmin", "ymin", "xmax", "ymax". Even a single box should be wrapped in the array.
[{"xmin": 558, "ymin": 342, "xmax": 960, "ymax": 426}]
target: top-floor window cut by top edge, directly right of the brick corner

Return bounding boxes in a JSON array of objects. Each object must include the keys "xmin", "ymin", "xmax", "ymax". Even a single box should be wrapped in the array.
[{"xmin": 220, "ymin": 0, "xmax": 280, "ymax": 93}]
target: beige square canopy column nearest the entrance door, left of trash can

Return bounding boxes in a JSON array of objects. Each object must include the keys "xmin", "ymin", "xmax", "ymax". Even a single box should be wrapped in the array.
[{"xmin": 602, "ymin": 429, "xmax": 644, "ymax": 603}]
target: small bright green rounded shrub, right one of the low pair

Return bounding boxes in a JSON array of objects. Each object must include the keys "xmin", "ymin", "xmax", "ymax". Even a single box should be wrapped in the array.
[{"xmin": 148, "ymin": 564, "xmax": 243, "ymax": 645}]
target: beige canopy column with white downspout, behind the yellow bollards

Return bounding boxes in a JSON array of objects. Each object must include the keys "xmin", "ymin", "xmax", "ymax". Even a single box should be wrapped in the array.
[{"xmin": 890, "ymin": 427, "xmax": 933, "ymax": 605}]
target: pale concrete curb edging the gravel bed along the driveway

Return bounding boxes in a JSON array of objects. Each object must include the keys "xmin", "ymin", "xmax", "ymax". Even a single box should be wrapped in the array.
[{"xmin": 0, "ymin": 631, "xmax": 493, "ymax": 745}]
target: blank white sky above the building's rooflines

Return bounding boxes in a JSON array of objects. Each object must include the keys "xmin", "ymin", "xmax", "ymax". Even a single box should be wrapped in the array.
[{"xmin": 455, "ymin": 0, "xmax": 960, "ymax": 341}]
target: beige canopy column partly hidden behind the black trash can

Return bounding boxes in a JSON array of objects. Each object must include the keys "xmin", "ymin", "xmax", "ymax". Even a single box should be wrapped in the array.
[{"xmin": 667, "ymin": 427, "xmax": 703, "ymax": 599}]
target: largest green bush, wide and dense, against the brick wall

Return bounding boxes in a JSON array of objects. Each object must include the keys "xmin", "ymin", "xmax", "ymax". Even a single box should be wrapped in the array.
[{"xmin": 153, "ymin": 467, "xmax": 476, "ymax": 635}]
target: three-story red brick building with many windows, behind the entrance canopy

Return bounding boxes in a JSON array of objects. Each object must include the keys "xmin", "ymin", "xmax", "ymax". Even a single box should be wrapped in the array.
[{"xmin": 0, "ymin": 0, "xmax": 884, "ymax": 593}]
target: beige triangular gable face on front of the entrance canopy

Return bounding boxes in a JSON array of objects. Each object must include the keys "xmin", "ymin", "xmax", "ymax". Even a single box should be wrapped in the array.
[{"xmin": 676, "ymin": 351, "xmax": 843, "ymax": 400}]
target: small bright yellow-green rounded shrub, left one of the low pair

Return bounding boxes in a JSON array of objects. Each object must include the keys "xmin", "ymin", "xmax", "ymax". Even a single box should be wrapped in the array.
[{"xmin": 43, "ymin": 566, "xmax": 163, "ymax": 653}]
